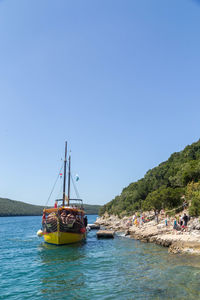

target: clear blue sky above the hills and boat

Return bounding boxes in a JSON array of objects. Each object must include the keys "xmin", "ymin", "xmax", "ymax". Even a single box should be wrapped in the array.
[{"xmin": 0, "ymin": 0, "xmax": 200, "ymax": 204}]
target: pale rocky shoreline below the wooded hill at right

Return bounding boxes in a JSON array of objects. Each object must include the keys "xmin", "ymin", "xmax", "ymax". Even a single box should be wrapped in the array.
[{"xmin": 95, "ymin": 214, "xmax": 200, "ymax": 254}]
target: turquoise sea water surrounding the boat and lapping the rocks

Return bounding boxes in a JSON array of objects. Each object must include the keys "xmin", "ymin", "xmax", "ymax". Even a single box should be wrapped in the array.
[{"xmin": 0, "ymin": 216, "xmax": 200, "ymax": 300}]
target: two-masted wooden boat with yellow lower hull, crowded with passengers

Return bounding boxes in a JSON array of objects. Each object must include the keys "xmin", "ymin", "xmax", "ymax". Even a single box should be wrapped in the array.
[{"xmin": 37, "ymin": 142, "xmax": 87, "ymax": 245}]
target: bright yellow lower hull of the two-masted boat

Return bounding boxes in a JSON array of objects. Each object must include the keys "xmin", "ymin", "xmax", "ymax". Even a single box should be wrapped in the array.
[{"xmin": 44, "ymin": 231, "xmax": 86, "ymax": 245}]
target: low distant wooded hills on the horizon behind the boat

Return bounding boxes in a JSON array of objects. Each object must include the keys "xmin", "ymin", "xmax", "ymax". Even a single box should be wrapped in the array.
[{"xmin": 0, "ymin": 198, "xmax": 101, "ymax": 217}]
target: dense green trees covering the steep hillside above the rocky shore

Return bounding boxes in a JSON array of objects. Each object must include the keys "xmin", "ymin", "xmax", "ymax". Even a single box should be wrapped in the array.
[{"xmin": 100, "ymin": 140, "xmax": 200, "ymax": 216}]
